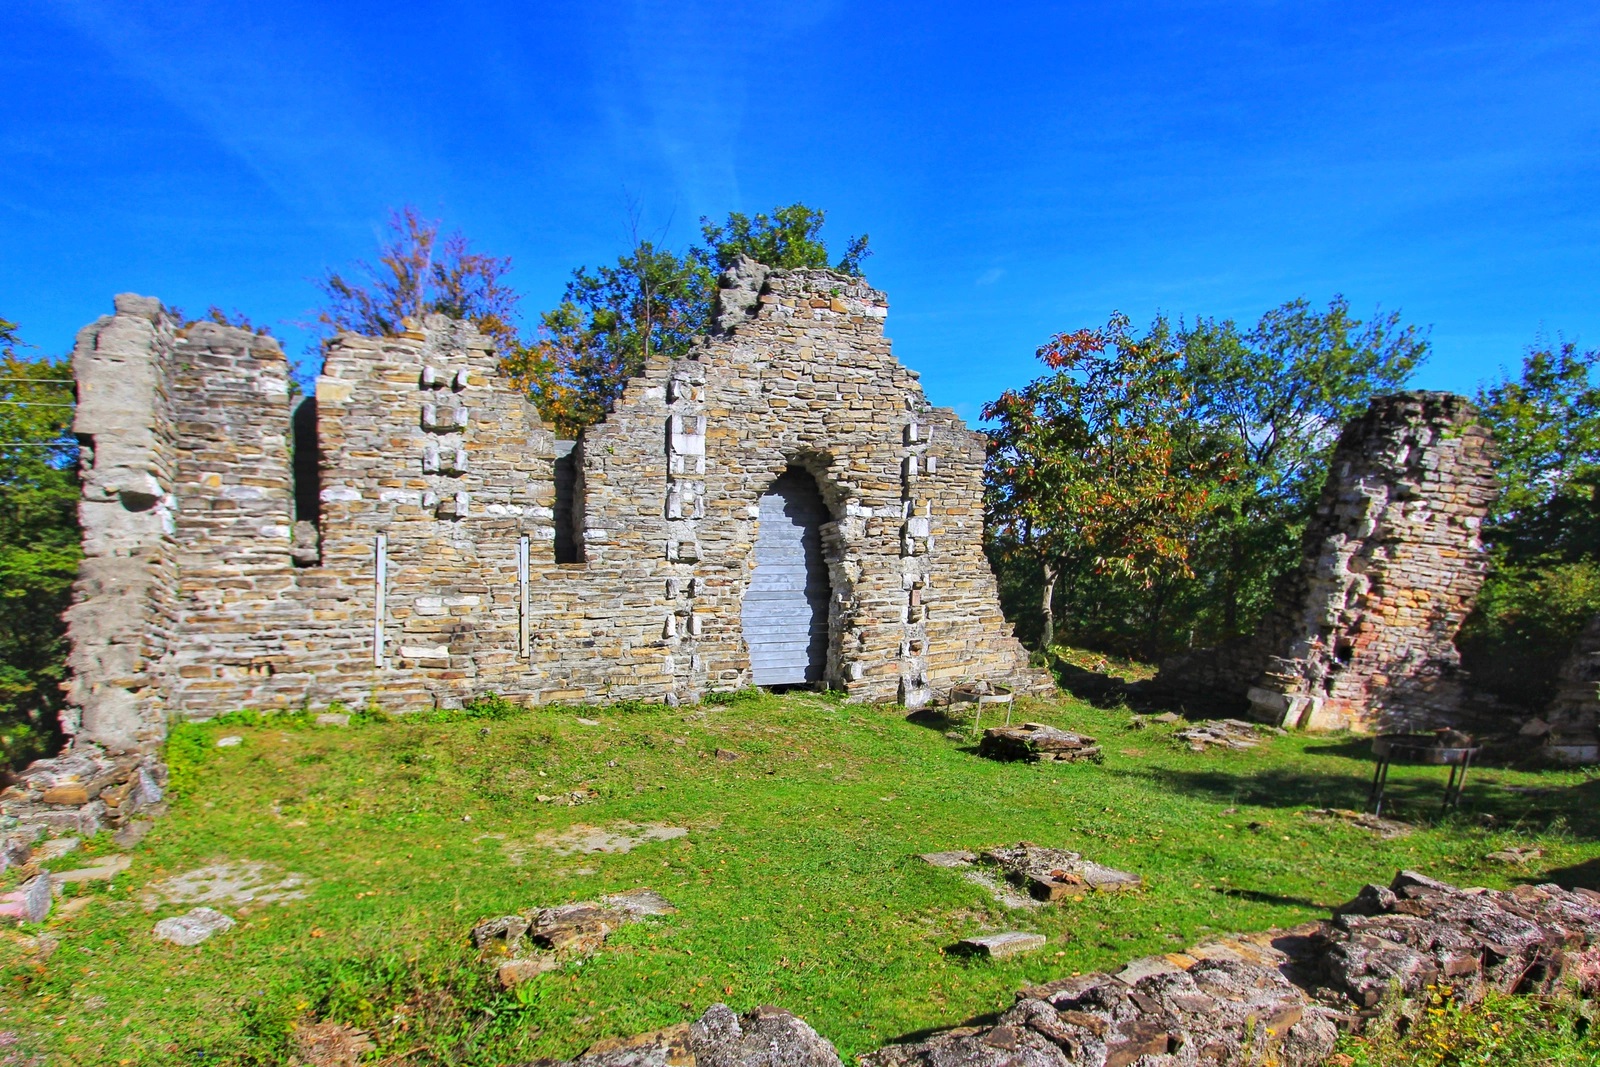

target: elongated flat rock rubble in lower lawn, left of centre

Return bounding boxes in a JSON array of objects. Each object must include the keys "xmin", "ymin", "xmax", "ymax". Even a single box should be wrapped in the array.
[{"xmin": 472, "ymin": 889, "xmax": 677, "ymax": 989}]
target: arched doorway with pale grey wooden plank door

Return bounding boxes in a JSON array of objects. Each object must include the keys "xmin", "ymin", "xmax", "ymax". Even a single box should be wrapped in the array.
[{"xmin": 741, "ymin": 467, "xmax": 832, "ymax": 686}]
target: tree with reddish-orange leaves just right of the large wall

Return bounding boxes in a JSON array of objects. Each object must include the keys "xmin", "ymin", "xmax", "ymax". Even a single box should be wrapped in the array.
[{"xmin": 982, "ymin": 315, "xmax": 1232, "ymax": 648}]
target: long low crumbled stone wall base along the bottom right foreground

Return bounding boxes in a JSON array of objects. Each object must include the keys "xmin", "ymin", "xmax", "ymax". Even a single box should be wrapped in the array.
[{"xmin": 540, "ymin": 870, "xmax": 1600, "ymax": 1067}]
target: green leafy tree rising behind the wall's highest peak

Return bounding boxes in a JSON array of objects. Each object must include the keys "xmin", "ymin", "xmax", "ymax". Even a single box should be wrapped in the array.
[{"xmin": 526, "ymin": 203, "xmax": 870, "ymax": 437}]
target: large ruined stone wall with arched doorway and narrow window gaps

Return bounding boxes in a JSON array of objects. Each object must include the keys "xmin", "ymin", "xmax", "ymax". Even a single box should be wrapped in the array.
[{"xmin": 13, "ymin": 261, "xmax": 1053, "ymax": 831}]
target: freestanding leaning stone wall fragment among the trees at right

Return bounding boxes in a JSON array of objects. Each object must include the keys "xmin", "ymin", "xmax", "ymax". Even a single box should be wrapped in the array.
[{"xmin": 1150, "ymin": 392, "xmax": 1496, "ymax": 733}]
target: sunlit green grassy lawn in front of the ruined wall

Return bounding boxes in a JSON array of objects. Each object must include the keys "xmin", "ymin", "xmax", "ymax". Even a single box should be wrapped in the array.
[{"xmin": 0, "ymin": 696, "xmax": 1600, "ymax": 1064}]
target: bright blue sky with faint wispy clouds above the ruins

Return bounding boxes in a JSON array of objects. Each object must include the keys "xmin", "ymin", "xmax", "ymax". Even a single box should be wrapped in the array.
[{"xmin": 0, "ymin": 0, "xmax": 1600, "ymax": 418}]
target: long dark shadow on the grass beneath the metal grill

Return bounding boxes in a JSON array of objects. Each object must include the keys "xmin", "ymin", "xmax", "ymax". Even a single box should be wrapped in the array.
[{"xmin": 1122, "ymin": 767, "xmax": 1600, "ymax": 840}]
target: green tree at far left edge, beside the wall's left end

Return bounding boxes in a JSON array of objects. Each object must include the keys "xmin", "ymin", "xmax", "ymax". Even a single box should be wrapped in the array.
[{"xmin": 0, "ymin": 320, "xmax": 82, "ymax": 766}]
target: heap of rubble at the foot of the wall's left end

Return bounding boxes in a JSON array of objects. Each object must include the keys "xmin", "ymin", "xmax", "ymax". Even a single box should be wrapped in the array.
[{"xmin": 0, "ymin": 745, "xmax": 166, "ymax": 841}]
